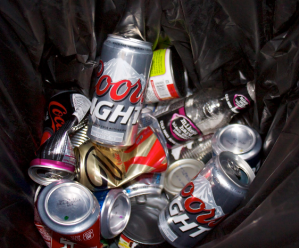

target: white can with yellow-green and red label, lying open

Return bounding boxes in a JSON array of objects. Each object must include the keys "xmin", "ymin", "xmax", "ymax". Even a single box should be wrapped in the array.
[{"xmin": 145, "ymin": 48, "xmax": 188, "ymax": 103}]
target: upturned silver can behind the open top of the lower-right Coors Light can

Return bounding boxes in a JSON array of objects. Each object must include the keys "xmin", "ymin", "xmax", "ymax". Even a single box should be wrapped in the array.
[{"xmin": 212, "ymin": 124, "xmax": 262, "ymax": 173}]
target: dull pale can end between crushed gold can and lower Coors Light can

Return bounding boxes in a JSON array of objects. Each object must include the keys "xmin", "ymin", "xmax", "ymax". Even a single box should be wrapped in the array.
[{"xmin": 164, "ymin": 159, "xmax": 205, "ymax": 195}]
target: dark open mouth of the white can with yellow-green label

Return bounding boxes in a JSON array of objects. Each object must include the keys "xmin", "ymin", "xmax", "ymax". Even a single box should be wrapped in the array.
[{"xmin": 171, "ymin": 48, "xmax": 187, "ymax": 97}]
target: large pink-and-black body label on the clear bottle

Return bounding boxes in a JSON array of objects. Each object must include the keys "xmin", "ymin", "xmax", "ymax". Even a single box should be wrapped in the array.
[{"xmin": 157, "ymin": 99, "xmax": 201, "ymax": 148}]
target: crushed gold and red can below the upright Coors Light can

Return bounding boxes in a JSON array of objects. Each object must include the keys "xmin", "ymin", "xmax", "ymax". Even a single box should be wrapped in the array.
[{"xmin": 75, "ymin": 127, "xmax": 167, "ymax": 191}]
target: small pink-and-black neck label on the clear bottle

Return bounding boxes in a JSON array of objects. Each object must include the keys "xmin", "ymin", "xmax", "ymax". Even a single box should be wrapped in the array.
[{"xmin": 224, "ymin": 86, "xmax": 251, "ymax": 114}]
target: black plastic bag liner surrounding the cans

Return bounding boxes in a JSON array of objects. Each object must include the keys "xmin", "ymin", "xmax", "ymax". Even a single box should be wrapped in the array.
[{"xmin": 0, "ymin": 0, "xmax": 299, "ymax": 248}]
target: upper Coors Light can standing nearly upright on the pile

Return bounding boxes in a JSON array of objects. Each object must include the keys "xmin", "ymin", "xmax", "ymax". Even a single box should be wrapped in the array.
[{"xmin": 88, "ymin": 35, "xmax": 153, "ymax": 147}]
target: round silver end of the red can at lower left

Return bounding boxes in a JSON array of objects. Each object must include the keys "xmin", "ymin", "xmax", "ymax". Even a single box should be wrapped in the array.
[{"xmin": 38, "ymin": 180, "xmax": 100, "ymax": 234}]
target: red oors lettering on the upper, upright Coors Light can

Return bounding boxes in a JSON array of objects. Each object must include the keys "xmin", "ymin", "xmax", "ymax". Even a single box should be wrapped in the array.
[{"xmin": 95, "ymin": 60, "xmax": 143, "ymax": 104}]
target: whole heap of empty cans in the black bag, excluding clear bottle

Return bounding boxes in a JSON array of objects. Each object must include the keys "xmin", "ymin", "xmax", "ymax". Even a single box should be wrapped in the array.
[{"xmin": 28, "ymin": 35, "xmax": 262, "ymax": 248}]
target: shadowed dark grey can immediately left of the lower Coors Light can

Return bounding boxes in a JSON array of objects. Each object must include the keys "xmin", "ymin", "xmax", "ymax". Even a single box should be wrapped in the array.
[{"xmin": 122, "ymin": 194, "xmax": 168, "ymax": 245}]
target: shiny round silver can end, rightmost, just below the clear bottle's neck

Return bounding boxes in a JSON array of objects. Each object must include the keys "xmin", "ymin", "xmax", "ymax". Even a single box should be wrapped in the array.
[{"xmin": 213, "ymin": 124, "xmax": 257, "ymax": 154}]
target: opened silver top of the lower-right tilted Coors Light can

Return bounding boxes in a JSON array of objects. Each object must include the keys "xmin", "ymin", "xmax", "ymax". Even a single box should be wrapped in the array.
[{"xmin": 216, "ymin": 152, "xmax": 255, "ymax": 188}]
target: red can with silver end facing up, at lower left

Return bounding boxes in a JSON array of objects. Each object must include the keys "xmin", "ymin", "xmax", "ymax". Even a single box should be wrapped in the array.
[{"xmin": 37, "ymin": 180, "xmax": 102, "ymax": 248}]
